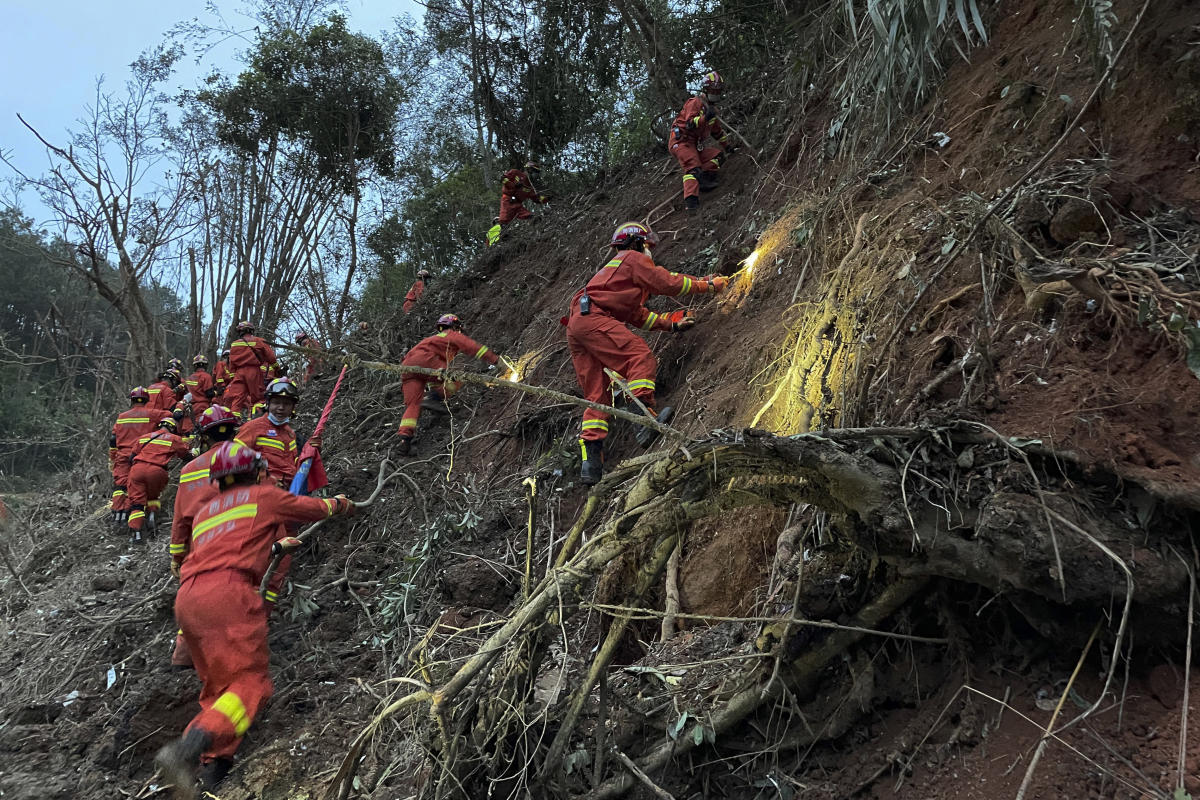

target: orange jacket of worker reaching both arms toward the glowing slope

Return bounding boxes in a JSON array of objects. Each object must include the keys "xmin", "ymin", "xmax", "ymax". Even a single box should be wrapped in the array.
[{"xmin": 563, "ymin": 249, "xmax": 713, "ymax": 331}]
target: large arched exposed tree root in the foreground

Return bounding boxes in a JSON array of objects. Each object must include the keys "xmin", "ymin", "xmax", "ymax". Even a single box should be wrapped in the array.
[{"xmin": 326, "ymin": 423, "xmax": 1189, "ymax": 800}]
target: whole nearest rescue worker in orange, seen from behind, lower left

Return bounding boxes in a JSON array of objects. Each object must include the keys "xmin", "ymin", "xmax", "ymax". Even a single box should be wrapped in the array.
[{"xmin": 155, "ymin": 441, "xmax": 354, "ymax": 798}]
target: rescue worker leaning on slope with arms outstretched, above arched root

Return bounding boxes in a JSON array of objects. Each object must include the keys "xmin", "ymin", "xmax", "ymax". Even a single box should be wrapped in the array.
[{"xmin": 564, "ymin": 222, "xmax": 728, "ymax": 486}]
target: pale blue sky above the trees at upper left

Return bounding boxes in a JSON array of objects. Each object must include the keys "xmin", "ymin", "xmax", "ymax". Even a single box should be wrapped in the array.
[{"xmin": 0, "ymin": 0, "xmax": 424, "ymax": 217}]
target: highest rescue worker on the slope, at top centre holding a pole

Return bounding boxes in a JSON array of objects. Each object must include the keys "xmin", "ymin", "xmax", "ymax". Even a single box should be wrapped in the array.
[{"xmin": 667, "ymin": 72, "xmax": 734, "ymax": 211}]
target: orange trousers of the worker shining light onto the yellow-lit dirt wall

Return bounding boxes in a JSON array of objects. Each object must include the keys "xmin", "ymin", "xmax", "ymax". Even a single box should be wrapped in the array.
[{"xmin": 566, "ymin": 311, "xmax": 659, "ymax": 441}]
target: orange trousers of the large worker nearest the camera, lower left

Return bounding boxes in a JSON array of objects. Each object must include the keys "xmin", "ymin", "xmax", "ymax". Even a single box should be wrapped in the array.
[{"xmin": 175, "ymin": 570, "xmax": 275, "ymax": 762}]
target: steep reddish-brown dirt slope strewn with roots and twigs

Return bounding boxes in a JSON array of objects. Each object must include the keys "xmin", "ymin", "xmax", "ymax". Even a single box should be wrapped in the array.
[{"xmin": 0, "ymin": 0, "xmax": 1200, "ymax": 800}]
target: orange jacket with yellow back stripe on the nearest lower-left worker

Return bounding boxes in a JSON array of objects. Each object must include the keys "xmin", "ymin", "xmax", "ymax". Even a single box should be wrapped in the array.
[{"xmin": 180, "ymin": 483, "xmax": 349, "ymax": 585}]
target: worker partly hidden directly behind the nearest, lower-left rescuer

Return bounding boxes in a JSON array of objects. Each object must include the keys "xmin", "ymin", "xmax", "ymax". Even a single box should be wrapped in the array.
[{"xmin": 168, "ymin": 405, "xmax": 241, "ymax": 667}]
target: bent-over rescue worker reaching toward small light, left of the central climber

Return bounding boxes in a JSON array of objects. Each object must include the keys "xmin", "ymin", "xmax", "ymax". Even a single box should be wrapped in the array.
[{"xmin": 396, "ymin": 314, "xmax": 500, "ymax": 456}]
